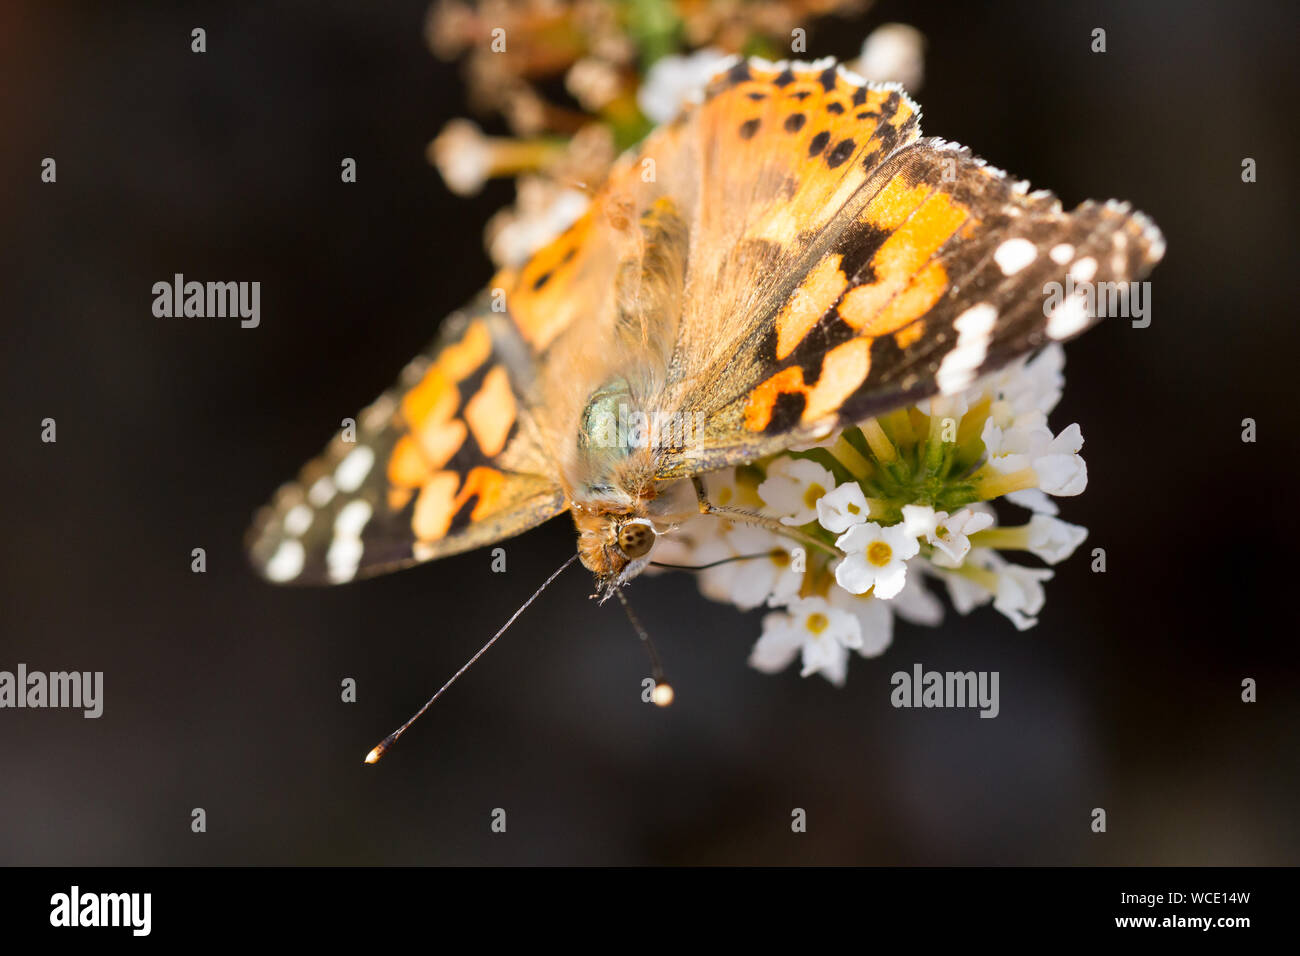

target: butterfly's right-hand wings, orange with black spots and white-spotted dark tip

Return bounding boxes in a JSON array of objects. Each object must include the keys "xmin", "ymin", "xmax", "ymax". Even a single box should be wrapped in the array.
[{"xmin": 618, "ymin": 60, "xmax": 1164, "ymax": 477}]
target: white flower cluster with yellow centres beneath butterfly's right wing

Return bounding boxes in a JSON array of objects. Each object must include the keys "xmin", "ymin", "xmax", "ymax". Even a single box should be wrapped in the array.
[{"xmin": 655, "ymin": 345, "xmax": 1088, "ymax": 684}]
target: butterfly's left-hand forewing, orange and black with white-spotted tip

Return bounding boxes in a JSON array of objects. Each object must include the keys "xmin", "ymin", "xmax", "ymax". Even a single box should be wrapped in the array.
[{"xmin": 248, "ymin": 297, "xmax": 568, "ymax": 584}]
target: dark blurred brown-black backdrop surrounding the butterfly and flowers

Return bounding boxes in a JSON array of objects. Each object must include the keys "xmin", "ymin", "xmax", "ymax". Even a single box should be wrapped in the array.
[{"xmin": 0, "ymin": 0, "xmax": 1300, "ymax": 864}]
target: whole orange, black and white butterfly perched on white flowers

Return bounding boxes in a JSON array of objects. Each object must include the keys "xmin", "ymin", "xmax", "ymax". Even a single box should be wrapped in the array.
[{"xmin": 250, "ymin": 60, "xmax": 1164, "ymax": 613}]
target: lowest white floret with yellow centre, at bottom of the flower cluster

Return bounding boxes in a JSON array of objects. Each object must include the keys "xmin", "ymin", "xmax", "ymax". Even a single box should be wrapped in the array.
[{"xmin": 749, "ymin": 597, "xmax": 862, "ymax": 684}]
